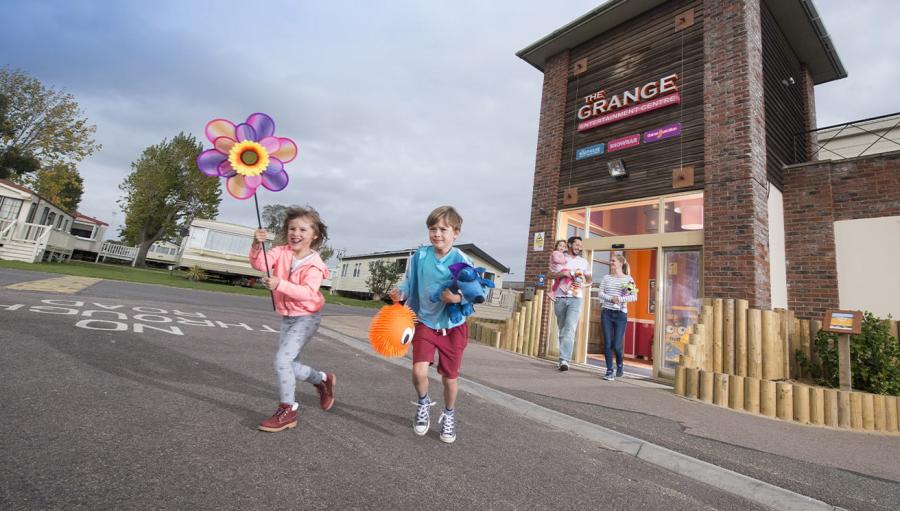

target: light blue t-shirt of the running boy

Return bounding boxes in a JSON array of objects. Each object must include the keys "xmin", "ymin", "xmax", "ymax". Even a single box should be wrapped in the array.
[{"xmin": 397, "ymin": 246, "xmax": 472, "ymax": 329}]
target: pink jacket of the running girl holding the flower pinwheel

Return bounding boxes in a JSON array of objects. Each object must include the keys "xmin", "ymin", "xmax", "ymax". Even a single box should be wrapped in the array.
[{"xmin": 250, "ymin": 245, "xmax": 328, "ymax": 316}]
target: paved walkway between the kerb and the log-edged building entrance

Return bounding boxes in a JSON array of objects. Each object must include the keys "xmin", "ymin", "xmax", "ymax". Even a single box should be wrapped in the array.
[{"xmin": 322, "ymin": 315, "xmax": 900, "ymax": 511}]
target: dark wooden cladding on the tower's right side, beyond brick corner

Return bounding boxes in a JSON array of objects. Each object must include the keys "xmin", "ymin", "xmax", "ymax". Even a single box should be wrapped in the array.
[{"xmin": 762, "ymin": 3, "xmax": 808, "ymax": 189}]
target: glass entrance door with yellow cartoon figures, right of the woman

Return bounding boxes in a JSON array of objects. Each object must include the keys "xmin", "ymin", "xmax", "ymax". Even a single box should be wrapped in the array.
[{"xmin": 658, "ymin": 247, "xmax": 703, "ymax": 377}]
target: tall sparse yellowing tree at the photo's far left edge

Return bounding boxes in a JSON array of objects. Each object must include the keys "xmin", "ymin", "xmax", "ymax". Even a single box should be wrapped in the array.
[{"xmin": 0, "ymin": 68, "xmax": 100, "ymax": 179}]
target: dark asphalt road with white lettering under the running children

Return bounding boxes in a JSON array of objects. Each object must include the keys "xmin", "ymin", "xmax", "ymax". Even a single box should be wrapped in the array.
[{"xmin": 0, "ymin": 269, "xmax": 759, "ymax": 510}]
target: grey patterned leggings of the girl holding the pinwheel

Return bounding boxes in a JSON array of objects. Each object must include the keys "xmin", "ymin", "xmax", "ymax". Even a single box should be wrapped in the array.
[{"xmin": 275, "ymin": 314, "xmax": 322, "ymax": 403}]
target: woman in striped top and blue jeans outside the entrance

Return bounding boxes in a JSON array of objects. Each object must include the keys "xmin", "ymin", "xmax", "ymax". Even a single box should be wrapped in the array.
[{"xmin": 599, "ymin": 254, "xmax": 637, "ymax": 381}]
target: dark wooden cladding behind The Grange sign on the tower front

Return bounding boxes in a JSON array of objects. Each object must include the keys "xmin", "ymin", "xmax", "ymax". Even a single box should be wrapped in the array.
[{"xmin": 558, "ymin": 0, "xmax": 704, "ymax": 207}]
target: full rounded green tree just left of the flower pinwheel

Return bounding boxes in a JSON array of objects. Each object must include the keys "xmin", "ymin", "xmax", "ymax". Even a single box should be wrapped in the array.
[{"xmin": 119, "ymin": 133, "xmax": 222, "ymax": 265}]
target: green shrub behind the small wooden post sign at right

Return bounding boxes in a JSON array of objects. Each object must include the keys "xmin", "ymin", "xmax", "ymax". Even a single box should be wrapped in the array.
[{"xmin": 796, "ymin": 312, "xmax": 900, "ymax": 396}]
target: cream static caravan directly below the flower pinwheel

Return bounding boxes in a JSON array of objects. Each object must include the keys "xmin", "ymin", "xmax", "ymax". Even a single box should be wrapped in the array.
[{"xmin": 176, "ymin": 219, "xmax": 265, "ymax": 283}]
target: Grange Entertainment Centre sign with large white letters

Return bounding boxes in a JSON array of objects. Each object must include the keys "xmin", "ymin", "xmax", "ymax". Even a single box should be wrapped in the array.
[{"xmin": 578, "ymin": 74, "xmax": 681, "ymax": 131}]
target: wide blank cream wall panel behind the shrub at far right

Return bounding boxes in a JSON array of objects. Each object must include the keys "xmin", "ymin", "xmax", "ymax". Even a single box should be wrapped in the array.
[{"xmin": 834, "ymin": 216, "xmax": 900, "ymax": 319}]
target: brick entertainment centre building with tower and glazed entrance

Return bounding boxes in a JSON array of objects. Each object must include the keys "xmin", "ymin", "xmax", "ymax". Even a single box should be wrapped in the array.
[{"xmin": 517, "ymin": 0, "xmax": 900, "ymax": 377}]
